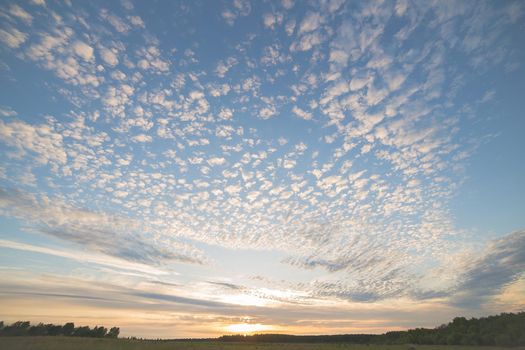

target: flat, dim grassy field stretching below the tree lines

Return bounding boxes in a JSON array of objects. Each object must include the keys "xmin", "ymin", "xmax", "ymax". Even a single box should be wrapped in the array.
[{"xmin": 0, "ymin": 337, "xmax": 525, "ymax": 350}]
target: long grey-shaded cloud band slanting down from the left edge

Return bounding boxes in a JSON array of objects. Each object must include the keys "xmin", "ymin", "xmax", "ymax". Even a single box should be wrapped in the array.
[{"xmin": 0, "ymin": 189, "xmax": 208, "ymax": 265}]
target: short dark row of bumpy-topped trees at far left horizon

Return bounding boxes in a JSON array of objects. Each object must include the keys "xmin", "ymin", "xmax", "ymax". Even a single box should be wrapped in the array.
[{"xmin": 0, "ymin": 321, "xmax": 120, "ymax": 338}]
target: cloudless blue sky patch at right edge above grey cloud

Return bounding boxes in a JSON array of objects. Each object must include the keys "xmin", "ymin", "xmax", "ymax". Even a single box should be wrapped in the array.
[{"xmin": 451, "ymin": 69, "xmax": 525, "ymax": 236}]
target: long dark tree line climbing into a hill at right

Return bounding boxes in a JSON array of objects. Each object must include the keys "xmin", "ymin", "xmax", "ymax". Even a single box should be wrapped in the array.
[{"xmin": 218, "ymin": 312, "xmax": 525, "ymax": 346}]
